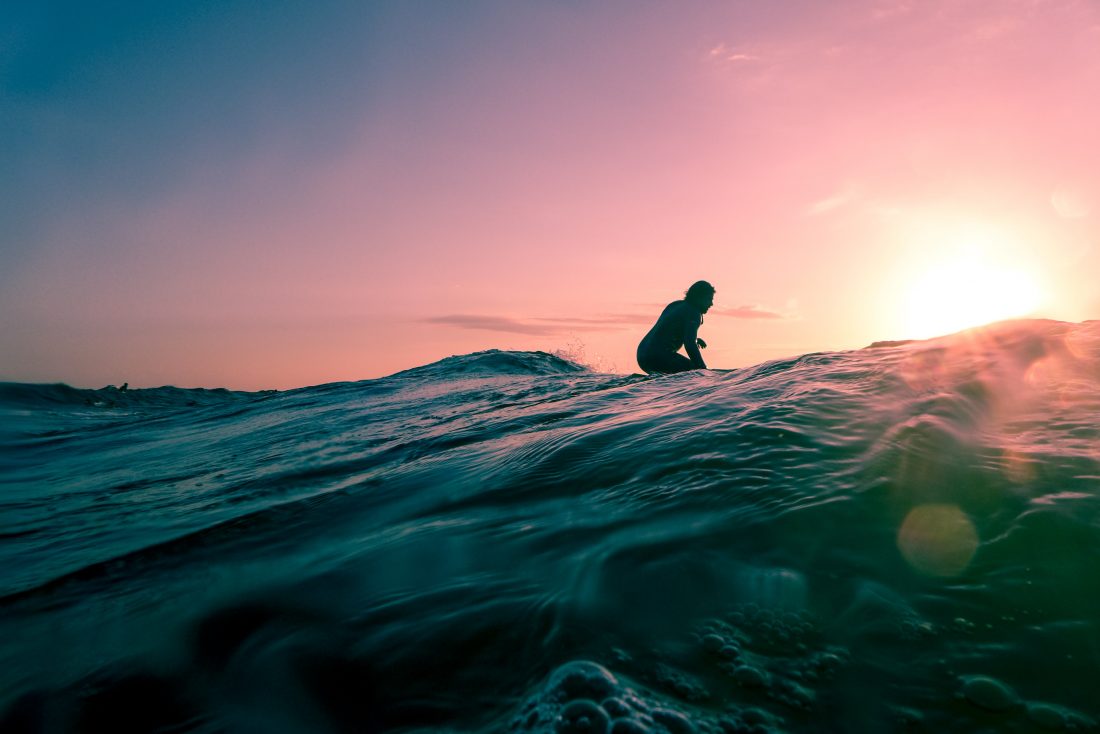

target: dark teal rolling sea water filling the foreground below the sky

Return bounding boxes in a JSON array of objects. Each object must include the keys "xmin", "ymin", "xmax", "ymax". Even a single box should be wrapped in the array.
[{"xmin": 0, "ymin": 321, "xmax": 1100, "ymax": 734}]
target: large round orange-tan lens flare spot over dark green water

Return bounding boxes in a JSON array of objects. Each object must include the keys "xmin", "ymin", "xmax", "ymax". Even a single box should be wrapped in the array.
[{"xmin": 898, "ymin": 504, "xmax": 978, "ymax": 577}]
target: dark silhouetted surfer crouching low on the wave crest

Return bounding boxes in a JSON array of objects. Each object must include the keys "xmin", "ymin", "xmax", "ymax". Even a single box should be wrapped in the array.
[{"xmin": 638, "ymin": 281, "xmax": 714, "ymax": 374}]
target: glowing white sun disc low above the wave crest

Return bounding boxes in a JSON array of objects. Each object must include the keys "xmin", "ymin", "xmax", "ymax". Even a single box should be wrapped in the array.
[{"xmin": 904, "ymin": 252, "xmax": 1042, "ymax": 339}]
